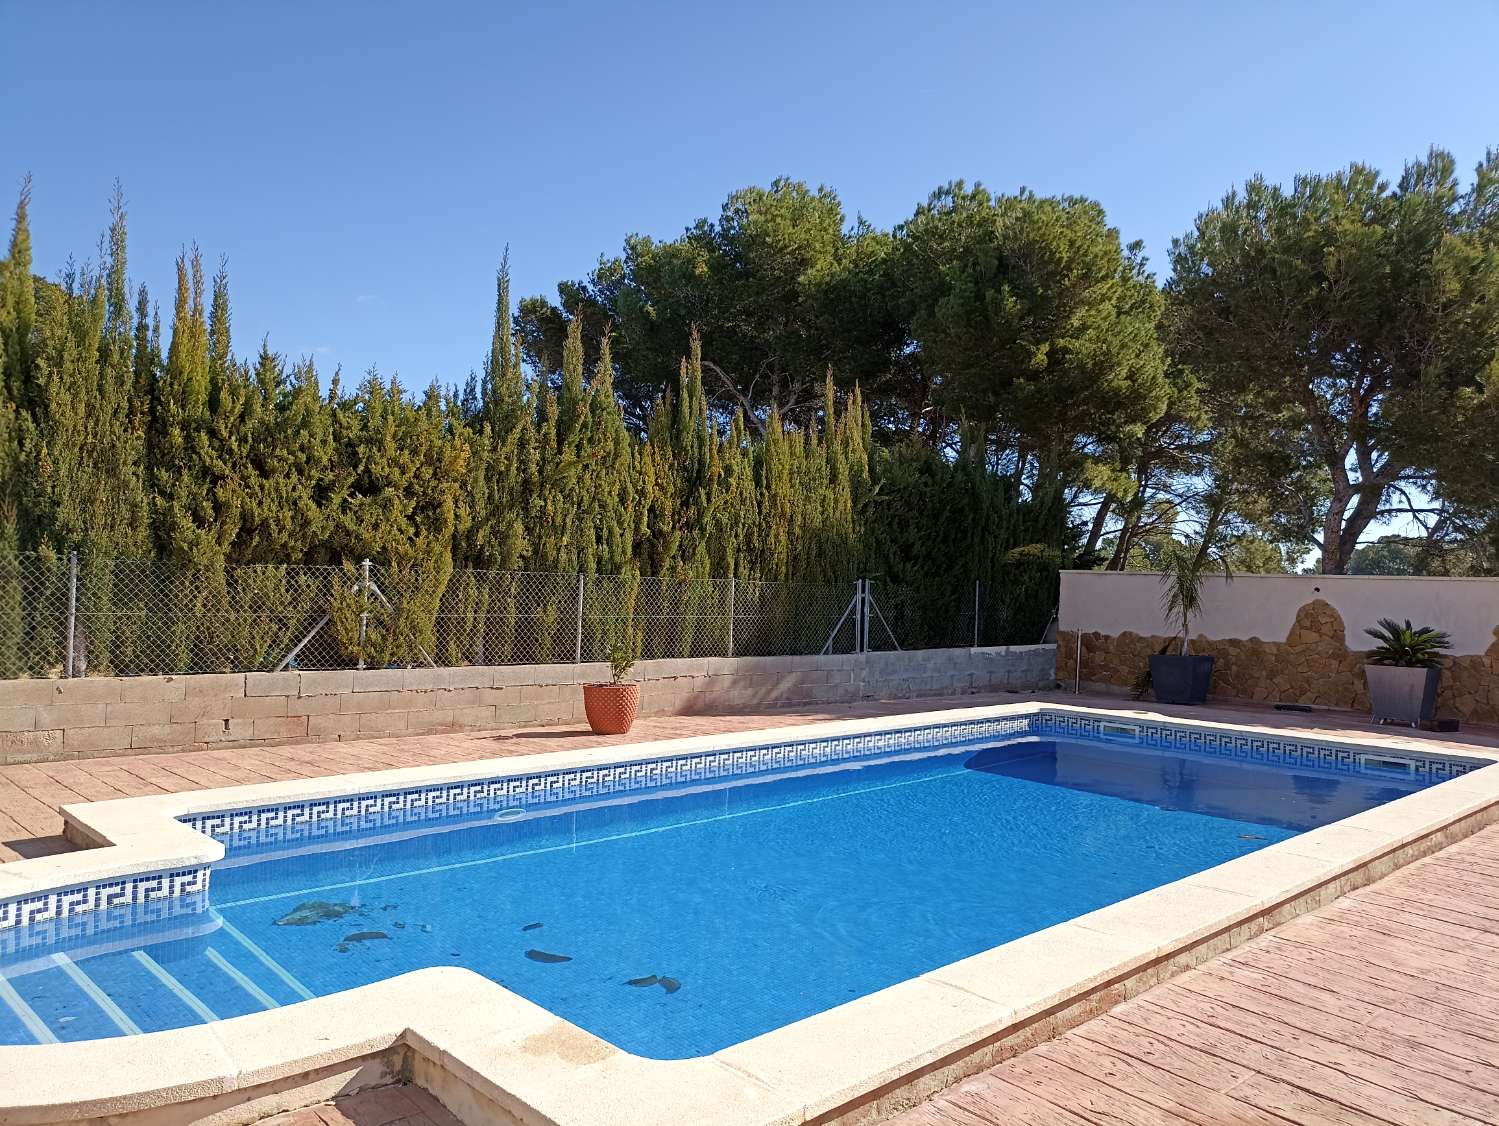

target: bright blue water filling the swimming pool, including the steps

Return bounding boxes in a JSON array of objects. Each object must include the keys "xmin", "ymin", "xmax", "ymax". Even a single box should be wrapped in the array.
[{"xmin": 0, "ymin": 736, "xmax": 1418, "ymax": 1059}]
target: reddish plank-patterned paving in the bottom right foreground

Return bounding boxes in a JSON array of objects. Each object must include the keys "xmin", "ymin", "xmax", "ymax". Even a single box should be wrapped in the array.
[{"xmin": 889, "ymin": 828, "xmax": 1499, "ymax": 1126}]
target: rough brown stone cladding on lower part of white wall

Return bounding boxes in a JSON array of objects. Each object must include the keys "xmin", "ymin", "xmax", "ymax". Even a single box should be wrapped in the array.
[{"xmin": 1057, "ymin": 598, "xmax": 1499, "ymax": 724}]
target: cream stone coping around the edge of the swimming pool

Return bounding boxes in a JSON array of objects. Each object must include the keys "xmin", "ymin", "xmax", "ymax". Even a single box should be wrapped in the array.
[{"xmin": 0, "ymin": 702, "xmax": 1499, "ymax": 1126}]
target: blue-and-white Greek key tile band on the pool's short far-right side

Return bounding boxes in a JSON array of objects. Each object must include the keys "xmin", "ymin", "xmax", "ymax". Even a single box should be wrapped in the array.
[{"xmin": 1034, "ymin": 711, "xmax": 1481, "ymax": 786}]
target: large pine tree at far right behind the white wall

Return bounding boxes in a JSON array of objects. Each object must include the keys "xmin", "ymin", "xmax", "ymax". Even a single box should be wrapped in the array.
[{"xmin": 1166, "ymin": 150, "xmax": 1499, "ymax": 573}]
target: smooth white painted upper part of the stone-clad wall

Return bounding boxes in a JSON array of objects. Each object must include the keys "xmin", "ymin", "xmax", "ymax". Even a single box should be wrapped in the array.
[{"xmin": 1058, "ymin": 571, "xmax": 1499, "ymax": 655}]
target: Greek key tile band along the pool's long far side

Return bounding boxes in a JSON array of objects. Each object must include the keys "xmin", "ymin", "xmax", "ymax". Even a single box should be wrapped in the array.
[{"xmin": 180, "ymin": 715, "xmax": 1036, "ymax": 852}]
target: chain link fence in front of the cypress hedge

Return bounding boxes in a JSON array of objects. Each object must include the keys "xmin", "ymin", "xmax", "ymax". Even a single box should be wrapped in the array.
[{"xmin": 0, "ymin": 555, "xmax": 1057, "ymax": 678}]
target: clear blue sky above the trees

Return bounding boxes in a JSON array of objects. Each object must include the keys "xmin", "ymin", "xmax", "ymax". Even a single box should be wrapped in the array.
[{"xmin": 0, "ymin": 0, "xmax": 1499, "ymax": 385}]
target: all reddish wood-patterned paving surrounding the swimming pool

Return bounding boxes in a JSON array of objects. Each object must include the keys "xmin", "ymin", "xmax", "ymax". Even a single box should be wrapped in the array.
[{"xmin": 0, "ymin": 693, "xmax": 1499, "ymax": 1126}]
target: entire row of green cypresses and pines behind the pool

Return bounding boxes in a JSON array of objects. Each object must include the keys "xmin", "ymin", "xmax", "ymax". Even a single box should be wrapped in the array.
[{"xmin": 0, "ymin": 143, "xmax": 1499, "ymax": 635}]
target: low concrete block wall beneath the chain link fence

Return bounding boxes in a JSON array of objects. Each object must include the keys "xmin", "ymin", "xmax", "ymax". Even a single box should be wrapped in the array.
[{"xmin": 0, "ymin": 645, "xmax": 1057, "ymax": 765}]
